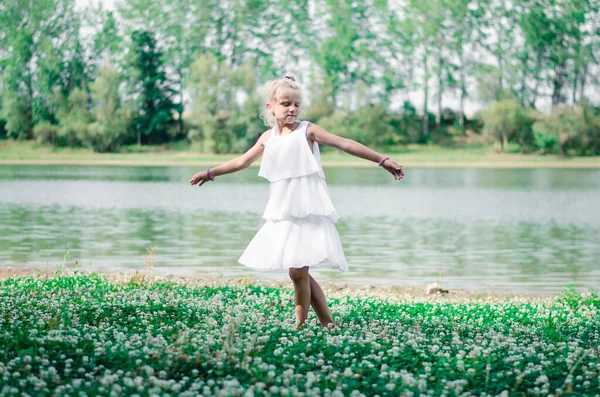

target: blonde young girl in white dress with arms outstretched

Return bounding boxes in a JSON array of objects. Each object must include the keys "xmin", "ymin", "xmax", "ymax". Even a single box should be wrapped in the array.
[{"xmin": 190, "ymin": 76, "xmax": 404, "ymax": 327}]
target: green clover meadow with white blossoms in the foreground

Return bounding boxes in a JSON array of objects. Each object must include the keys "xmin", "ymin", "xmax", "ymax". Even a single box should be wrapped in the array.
[{"xmin": 0, "ymin": 270, "xmax": 600, "ymax": 396}]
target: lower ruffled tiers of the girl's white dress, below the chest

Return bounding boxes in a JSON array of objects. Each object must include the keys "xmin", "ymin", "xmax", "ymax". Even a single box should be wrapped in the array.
[{"xmin": 238, "ymin": 173, "xmax": 348, "ymax": 271}]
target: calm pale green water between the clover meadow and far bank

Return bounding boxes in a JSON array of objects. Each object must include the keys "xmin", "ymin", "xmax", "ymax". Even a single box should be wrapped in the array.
[{"xmin": 0, "ymin": 166, "xmax": 600, "ymax": 294}]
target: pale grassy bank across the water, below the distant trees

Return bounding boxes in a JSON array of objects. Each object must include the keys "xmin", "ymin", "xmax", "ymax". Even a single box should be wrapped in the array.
[{"xmin": 0, "ymin": 140, "xmax": 600, "ymax": 168}]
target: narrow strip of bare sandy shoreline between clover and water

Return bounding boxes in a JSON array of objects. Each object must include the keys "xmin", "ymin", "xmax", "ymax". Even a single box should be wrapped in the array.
[{"xmin": 0, "ymin": 266, "xmax": 559, "ymax": 302}]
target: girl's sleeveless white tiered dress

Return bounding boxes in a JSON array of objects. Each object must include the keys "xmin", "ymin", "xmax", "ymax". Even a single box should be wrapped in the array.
[{"xmin": 238, "ymin": 121, "xmax": 348, "ymax": 271}]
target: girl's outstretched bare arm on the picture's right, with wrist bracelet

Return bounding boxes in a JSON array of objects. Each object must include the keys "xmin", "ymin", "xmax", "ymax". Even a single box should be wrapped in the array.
[{"xmin": 307, "ymin": 123, "xmax": 404, "ymax": 180}]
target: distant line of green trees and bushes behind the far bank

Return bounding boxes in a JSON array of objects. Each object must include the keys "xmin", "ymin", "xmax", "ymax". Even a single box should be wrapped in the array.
[{"xmin": 0, "ymin": 0, "xmax": 600, "ymax": 155}]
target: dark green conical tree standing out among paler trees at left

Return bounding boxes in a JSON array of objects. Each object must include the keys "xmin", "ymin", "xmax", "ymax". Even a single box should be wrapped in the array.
[{"xmin": 128, "ymin": 30, "xmax": 177, "ymax": 145}]
